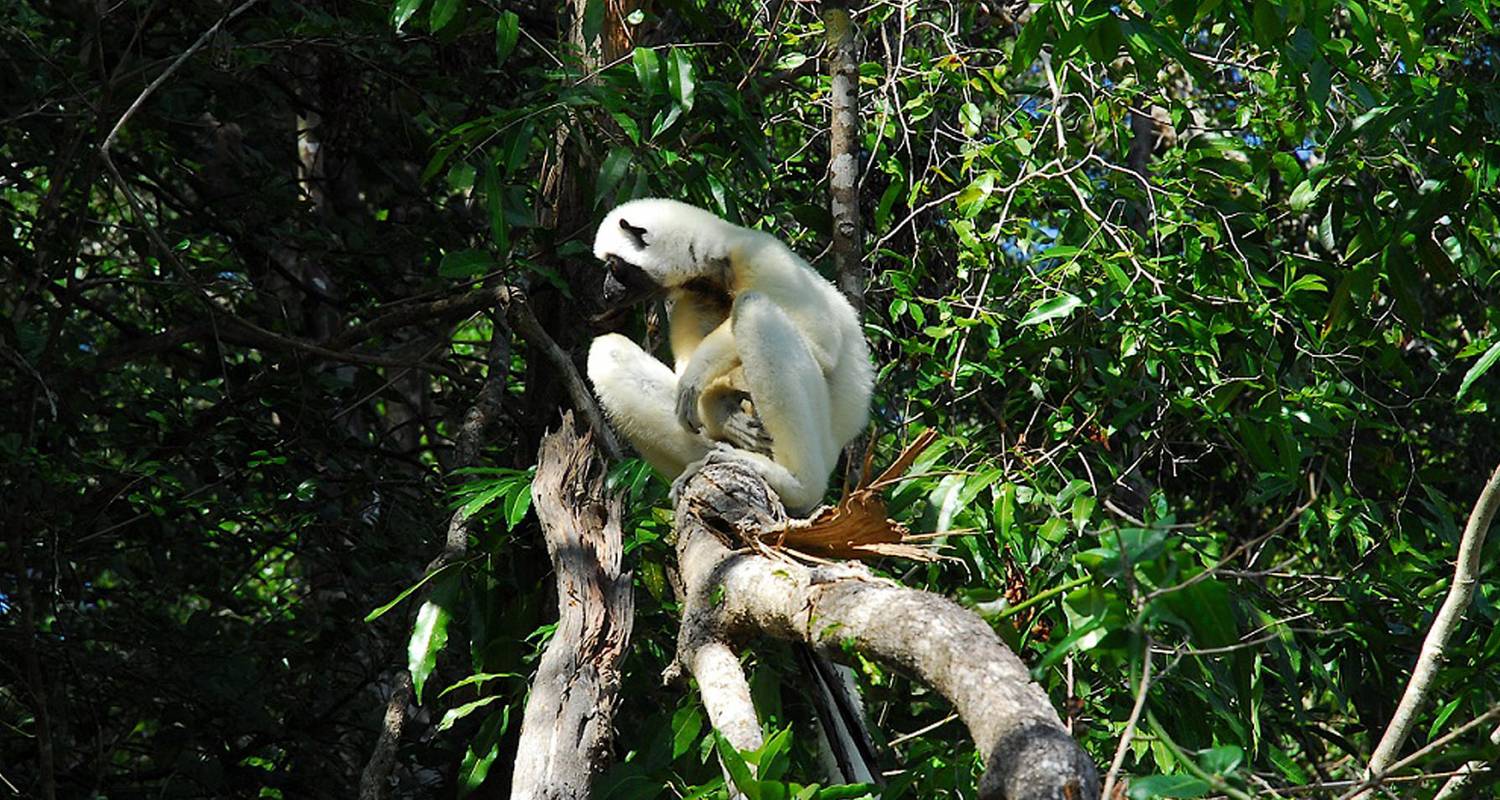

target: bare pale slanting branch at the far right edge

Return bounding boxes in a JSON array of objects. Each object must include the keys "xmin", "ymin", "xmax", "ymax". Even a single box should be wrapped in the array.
[{"xmin": 1367, "ymin": 467, "xmax": 1500, "ymax": 774}]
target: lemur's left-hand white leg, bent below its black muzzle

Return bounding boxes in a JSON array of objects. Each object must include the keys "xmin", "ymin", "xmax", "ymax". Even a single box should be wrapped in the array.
[{"xmin": 588, "ymin": 333, "xmax": 708, "ymax": 480}]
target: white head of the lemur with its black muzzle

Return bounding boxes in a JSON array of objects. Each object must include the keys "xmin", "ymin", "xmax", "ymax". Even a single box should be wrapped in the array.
[{"xmin": 594, "ymin": 198, "xmax": 738, "ymax": 306}]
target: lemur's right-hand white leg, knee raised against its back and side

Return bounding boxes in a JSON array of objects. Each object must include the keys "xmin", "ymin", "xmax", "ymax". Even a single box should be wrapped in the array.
[{"xmin": 732, "ymin": 291, "xmax": 839, "ymax": 510}]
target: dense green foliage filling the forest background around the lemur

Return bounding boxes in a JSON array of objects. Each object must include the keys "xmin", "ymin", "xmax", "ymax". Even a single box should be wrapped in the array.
[{"xmin": 0, "ymin": 0, "xmax": 1500, "ymax": 797}]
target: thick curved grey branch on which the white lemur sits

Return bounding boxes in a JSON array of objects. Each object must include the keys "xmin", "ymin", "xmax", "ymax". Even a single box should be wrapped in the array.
[{"xmin": 677, "ymin": 458, "xmax": 1100, "ymax": 800}]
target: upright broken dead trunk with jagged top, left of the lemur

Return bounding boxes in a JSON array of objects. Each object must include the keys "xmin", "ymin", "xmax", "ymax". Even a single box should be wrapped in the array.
[{"xmin": 510, "ymin": 413, "xmax": 635, "ymax": 798}]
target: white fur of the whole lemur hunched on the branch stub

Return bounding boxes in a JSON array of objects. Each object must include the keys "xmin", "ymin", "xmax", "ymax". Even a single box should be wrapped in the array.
[{"xmin": 588, "ymin": 200, "xmax": 875, "ymax": 510}]
